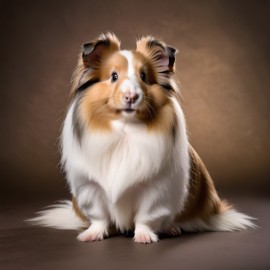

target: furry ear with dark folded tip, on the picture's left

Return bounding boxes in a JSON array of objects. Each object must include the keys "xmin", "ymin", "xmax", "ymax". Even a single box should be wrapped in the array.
[{"xmin": 82, "ymin": 33, "xmax": 120, "ymax": 69}]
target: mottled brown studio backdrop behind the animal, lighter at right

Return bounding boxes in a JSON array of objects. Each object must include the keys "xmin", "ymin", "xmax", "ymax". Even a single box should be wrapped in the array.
[{"xmin": 0, "ymin": 0, "xmax": 270, "ymax": 199}]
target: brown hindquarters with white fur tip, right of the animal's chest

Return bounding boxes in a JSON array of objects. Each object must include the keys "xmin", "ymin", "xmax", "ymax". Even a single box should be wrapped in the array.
[{"xmin": 176, "ymin": 146, "xmax": 257, "ymax": 232}]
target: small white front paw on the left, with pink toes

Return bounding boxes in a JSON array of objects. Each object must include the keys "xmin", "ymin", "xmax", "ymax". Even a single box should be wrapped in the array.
[{"xmin": 77, "ymin": 222, "xmax": 108, "ymax": 242}]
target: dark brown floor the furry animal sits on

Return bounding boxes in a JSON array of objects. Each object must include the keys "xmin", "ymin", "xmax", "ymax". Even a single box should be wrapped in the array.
[{"xmin": 0, "ymin": 197, "xmax": 270, "ymax": 270}]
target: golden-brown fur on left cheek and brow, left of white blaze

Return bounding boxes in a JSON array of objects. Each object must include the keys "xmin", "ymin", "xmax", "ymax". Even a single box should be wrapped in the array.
[{"xmin": 77, "ymin": 53, "xmax": 131, "ymax": 131}]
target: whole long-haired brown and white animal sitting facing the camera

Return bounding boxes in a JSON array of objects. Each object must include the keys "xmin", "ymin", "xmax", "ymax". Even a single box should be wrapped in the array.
[{"xmin": 28, "ymin": 33, "xmax": 255, "ymax": 243}]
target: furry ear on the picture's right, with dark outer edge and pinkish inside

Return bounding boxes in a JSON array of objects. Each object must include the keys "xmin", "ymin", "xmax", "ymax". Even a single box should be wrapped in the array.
[{"xmin": 137, "ymin": 36, "xmax": 177, "ymax": 89}]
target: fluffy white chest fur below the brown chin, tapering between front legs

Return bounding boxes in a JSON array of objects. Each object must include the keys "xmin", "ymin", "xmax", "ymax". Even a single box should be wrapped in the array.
[{"xmin": 62, "ymin": 103, "xmax": 173, "ymax": 196}]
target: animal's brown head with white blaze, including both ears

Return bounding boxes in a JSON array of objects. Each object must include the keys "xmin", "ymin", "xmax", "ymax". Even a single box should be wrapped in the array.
[{"xmin": 72, "ymin": 33, "xmax": 178, "ymax": 132}]
